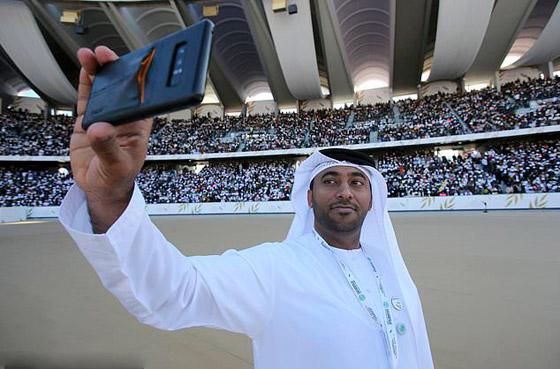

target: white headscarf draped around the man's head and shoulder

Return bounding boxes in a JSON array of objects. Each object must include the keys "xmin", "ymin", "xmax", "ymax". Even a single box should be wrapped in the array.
[{"xmin": 286, "ymin": 149, "xmax": 433, "ymax": 369}]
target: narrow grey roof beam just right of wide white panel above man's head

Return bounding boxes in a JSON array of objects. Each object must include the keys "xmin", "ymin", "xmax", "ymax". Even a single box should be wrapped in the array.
[{"xmin": 313, "ymin": 0, "xmax": 354, "ymax": 102}]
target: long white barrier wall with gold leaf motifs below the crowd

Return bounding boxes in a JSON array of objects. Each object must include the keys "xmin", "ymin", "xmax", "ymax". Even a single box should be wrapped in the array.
[{"xmin": 0, "ymin": 193, "xmax": 560, "ymax": 222}]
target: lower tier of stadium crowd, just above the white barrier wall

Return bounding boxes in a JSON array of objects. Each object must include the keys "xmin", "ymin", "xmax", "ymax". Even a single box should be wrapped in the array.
[{"xmin": 0, "ymin": 139, "xmax": 560, "ymax": 206}]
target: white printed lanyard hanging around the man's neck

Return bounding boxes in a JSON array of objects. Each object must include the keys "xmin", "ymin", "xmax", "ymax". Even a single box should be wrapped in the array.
[{"xmin": 313, "ymin": 230, "xmax": 399, "ymax": 369}]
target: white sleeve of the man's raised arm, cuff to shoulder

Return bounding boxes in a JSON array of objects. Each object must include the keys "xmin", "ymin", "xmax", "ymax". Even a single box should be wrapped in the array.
[{"xmin": 60, "ymin": 185, "xmax": 276, "ymax": 337}]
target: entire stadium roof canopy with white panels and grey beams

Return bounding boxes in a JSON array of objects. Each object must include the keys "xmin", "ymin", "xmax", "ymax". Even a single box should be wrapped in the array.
[{"xmin": 0, "ymin": 0, "xmax": 560, "ymax": 111}]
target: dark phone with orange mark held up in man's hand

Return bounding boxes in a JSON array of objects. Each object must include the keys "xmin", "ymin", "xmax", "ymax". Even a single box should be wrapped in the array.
[{"xmin": 82, "ymin": 20, "xmax": 214, "ymax": 130}]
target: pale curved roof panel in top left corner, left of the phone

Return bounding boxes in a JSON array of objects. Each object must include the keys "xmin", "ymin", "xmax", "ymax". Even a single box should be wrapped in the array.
[{"xmin": 0, "ymin": 0, "xmax": 78, "ymax": 106}]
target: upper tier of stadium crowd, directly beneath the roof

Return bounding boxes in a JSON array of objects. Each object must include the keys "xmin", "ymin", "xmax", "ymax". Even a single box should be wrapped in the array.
[{"xmin": 0, "ymin": 77, "xmax": 560, "ymax": 155}]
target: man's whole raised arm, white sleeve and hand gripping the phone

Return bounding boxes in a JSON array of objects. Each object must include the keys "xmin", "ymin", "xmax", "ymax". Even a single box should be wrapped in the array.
[{"xmin": 60, "ymin": 47, "xmax": 275, "ymax": 336}]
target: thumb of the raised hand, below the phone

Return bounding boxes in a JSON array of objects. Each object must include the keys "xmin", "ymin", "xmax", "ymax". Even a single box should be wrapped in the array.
[{"xmin": 87, "ymin": 122, "xmax": 123, "ymax": 165}]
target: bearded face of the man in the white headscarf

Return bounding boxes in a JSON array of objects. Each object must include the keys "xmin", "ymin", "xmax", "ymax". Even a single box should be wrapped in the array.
[{"xmin": 307, "ymin": 166, "xmax": 372, "ymax": 232}]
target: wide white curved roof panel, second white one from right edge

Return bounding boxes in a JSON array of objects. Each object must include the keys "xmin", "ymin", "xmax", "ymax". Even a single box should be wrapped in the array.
[{"xmin": 429, "ymin": 0, "xmax": 494, "ymax": 81}]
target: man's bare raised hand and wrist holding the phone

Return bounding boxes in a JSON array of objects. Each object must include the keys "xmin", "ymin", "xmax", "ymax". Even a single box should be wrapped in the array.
[{"xmin": 70, "ymin": 46, "xmax": 152, "ymax": 233}]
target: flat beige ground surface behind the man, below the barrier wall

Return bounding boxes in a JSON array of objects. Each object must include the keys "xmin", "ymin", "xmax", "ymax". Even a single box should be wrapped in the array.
[{"xmin": 0, "ymin": 211, "xmax": 560, "ymax": 369}]
